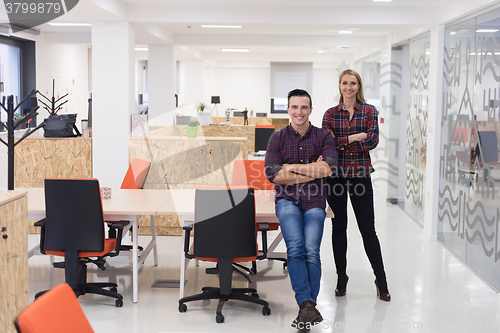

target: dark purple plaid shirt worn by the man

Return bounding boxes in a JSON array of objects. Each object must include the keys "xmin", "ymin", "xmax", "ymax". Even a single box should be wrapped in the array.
[{"xmin": 265, "ymin": 124, "xmax": 337, "ymax": 210}]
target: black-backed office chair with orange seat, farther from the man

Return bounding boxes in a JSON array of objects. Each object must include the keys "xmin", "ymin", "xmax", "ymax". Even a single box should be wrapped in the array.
[{"xmin": 35, "ymin": 178, "xmax": 129, "ymax": 307}]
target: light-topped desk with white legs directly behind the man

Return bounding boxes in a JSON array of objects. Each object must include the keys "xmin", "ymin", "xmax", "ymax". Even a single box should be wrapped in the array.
[{"xmin": 157, "ymin": 190, "xmax": 333, "ymax": 298}]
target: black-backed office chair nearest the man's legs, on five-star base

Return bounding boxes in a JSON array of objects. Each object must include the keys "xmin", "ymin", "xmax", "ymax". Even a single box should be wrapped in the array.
[{"xmin": 179, "ymin": 188, "xmax": 271, "ymax": 323}]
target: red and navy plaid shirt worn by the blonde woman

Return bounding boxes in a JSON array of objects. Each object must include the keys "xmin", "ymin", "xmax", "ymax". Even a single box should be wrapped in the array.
[{"xmin": 322, "ymin": 102, "xmax": 379, "ymax": 178}]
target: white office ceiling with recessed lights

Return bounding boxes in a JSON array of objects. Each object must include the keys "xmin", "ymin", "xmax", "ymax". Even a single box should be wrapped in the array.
[{"xmin": 0, "ymin": 0, "xmax": 500, "ymax": 62}]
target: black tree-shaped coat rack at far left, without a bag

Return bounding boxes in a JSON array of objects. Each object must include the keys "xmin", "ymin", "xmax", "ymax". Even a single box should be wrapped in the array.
[{"xmin": 0, "ymin": 89, "xmax": 45, "ymax": 190}]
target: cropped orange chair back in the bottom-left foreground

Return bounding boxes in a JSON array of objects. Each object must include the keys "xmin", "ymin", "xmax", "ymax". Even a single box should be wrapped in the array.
[{"xmin": 14, "ymin": 283, "xmax": 94, "ymax": 333}]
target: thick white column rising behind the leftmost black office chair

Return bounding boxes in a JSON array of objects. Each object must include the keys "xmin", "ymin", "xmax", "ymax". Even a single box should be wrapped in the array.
[{"xmin": 92, "ymin": 22, "xmax": 135, "ymax": 188}]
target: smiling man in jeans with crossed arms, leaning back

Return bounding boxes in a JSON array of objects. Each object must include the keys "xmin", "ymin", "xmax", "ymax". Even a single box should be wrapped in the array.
[{"xmin": 265, "ymin": 89, "xmax": 337, "ymax": 329}]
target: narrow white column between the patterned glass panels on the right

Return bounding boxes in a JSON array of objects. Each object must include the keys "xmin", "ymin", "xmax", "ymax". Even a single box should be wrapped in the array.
[{"xmin": 424, "ymin": 25, "xmax": 444, "ymax": 240}]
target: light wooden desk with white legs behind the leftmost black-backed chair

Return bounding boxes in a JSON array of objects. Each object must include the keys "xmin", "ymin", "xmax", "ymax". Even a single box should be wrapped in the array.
[{"xmin": 27, "ymin": 188, "xmax": 171, "ymax": 303}]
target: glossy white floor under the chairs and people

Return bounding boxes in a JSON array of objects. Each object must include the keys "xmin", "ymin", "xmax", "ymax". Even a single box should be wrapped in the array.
[{"xmin": 29, "ymin": 192, "xmax": 500, "ymax": 333}]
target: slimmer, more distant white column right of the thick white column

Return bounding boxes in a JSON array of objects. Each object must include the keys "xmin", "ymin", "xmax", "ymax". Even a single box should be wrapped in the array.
[{"xmin": 148, "ymin": 44, "xmax": 175, "ymax": 126}]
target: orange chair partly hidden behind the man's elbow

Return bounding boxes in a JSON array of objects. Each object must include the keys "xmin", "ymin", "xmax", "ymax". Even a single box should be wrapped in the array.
[{"xmin": 231, "ymin": 160, "xmax": 286, "ymax": 274}]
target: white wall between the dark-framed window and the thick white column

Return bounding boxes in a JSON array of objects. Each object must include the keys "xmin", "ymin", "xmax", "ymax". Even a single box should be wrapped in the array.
[{"xmin": 36, "ymin": 40, "xmax": 89, "ymax": 129}]
